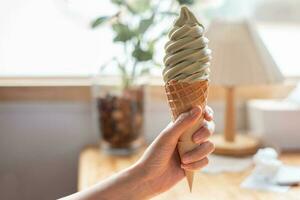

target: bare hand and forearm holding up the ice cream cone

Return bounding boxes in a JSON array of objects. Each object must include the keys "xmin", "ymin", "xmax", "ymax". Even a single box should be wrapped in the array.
[{"xmin": 63, "ymin": 107, "xmax": 214, "ymax": 200}]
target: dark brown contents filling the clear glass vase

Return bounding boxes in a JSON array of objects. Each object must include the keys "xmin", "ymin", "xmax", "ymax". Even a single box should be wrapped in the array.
[{"xmin": 97, "ymin": 88, "xmax": 144, "ymax": 148}]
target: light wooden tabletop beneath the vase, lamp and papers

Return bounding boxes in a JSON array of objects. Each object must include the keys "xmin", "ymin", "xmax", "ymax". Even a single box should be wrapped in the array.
[{"xmin": 78, "ymin": 146, "xmax": 300, "ymax": 200}]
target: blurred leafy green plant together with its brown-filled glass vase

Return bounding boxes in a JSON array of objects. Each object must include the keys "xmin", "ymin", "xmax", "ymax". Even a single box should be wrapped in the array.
[{"xmin": 91, "ymin": 0, "xmax": 198, "ymax": 154}]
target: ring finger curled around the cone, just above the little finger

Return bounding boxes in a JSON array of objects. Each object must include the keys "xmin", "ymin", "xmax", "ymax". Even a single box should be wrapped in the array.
[{"xmin": 181, "ymin": 141, "xmax": 215, "ymax": 164}]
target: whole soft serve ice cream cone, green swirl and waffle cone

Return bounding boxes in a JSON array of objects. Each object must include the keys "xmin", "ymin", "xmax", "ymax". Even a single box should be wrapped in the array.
[{"xmin": 163, "ymin": 6, "xmax": 211, "ymax": 191}]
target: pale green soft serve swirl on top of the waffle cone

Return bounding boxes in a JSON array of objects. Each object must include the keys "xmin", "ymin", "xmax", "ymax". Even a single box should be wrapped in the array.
[{"xmin": 163, "ymin": 6, "xmax": 211, "ymax": 83}]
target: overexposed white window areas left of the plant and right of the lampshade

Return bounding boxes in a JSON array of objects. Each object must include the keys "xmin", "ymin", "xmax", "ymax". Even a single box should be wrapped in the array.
[{"xmin": 0, "ymin": 0, "xmax": 300, "ymax": 77}]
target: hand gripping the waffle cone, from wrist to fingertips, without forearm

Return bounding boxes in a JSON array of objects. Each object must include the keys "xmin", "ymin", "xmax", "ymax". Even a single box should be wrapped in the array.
[{"xmin": 135, "ymin": 107, "xmax": 214, "ymax": 195}]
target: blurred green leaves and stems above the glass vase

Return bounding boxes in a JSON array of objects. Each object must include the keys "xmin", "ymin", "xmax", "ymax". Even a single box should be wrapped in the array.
[{"xmin": 91, "ymin": 0, "xmax": 198, "ymax": 88}]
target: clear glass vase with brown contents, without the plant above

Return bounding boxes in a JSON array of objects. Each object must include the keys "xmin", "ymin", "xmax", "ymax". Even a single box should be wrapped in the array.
[{"xmin": 93, "ymin": 79, "xmax": 144, "ymax": 155}]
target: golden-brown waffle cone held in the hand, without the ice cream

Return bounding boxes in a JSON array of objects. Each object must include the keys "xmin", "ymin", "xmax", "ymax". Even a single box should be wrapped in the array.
[{"xmin": 165, "ymin": 80, "xmax": 209, "ymax": 191}]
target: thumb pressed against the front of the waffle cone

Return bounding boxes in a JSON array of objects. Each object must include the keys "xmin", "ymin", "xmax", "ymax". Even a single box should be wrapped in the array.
[{"xmin": 161, "ymin": 106, "xmax": 202, "ymax": 143}]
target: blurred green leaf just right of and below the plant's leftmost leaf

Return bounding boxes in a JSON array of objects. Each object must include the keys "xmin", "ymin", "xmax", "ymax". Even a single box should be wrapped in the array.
[{"xmin": 112, "ymin": 23, "xmax": 136, "ymax": 42}]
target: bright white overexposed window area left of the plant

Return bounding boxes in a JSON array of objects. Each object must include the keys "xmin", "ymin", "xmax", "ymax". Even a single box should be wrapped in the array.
[{"xmin": 0, "ymin": 0, "xmax": 117, "ymax": 76}]
